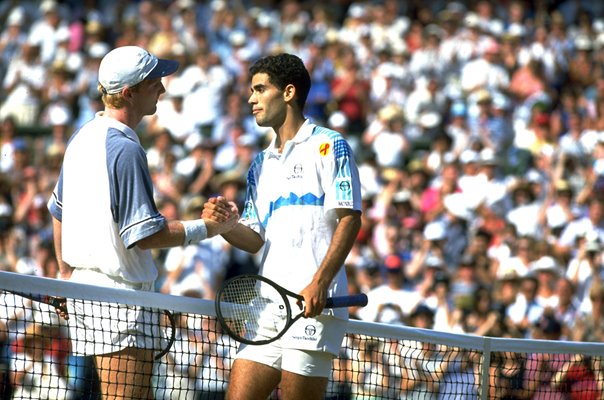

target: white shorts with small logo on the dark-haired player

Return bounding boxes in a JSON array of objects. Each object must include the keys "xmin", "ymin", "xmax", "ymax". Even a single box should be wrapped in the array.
[{"xmin": 235, "ymin": 315, "xmax": 347, "ymax": 378}]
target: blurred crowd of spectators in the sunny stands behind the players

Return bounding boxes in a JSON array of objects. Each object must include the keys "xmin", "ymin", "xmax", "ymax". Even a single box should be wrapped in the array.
[{"xmin": 0, "ymin": 0, "xmax": 604, "ymax": 350}]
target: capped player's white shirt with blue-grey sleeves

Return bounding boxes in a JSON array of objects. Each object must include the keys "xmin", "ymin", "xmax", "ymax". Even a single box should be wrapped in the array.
[{"xmin": 48, "ymin": 113, "xmax": 166, "ymax": 283}]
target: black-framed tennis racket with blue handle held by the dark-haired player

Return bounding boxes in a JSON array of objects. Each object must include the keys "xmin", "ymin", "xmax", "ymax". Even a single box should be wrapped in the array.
[{"xmin": 216, "ymin": 274, "xmax": 367, "ymax": 345}]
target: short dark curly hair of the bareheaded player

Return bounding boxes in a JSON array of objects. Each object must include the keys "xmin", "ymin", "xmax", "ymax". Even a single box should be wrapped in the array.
[{"xmin": 250, "ymin": 53, "xmax": 310, "ymax": 110}]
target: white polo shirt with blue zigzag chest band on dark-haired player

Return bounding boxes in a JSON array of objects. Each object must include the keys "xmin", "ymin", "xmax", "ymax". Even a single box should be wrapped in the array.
[{"xmin": 240, "ymin": 121, "xmax": 361, "ymax": 318}]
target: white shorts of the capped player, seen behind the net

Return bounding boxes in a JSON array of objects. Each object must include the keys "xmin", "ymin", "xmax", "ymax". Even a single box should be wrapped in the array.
[{"xmin": 67, "ymin": 268, "xmax": 161, "ymax": 355}]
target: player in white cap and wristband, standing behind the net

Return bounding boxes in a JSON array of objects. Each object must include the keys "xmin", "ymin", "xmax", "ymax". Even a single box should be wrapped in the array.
[{"xmin": 48, "ymin": 46, "xmax": 239, "ymax": 399}]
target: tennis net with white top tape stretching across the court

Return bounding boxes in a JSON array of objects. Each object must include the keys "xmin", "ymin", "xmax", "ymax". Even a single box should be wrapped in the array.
[{"xmin": 0, "ymin": 272, "xmax": 604, "ymax": 400}]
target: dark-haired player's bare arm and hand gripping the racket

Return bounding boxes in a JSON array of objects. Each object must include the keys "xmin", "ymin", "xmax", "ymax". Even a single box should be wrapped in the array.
[{"xmin": 300, "ymin": 208, "xmax": 361, "ymax": 317}]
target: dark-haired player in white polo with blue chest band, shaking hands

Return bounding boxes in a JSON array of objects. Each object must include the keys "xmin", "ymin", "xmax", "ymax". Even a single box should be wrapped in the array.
[{"xmin": 202, "ymin": 54, "xmax": 361, "ymax": 400}]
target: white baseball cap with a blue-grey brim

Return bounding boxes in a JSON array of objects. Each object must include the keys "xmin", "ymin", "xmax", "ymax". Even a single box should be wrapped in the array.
[{"xmin": 99, "ymin": 46, "xmax": 179, "ymax": 94}]
